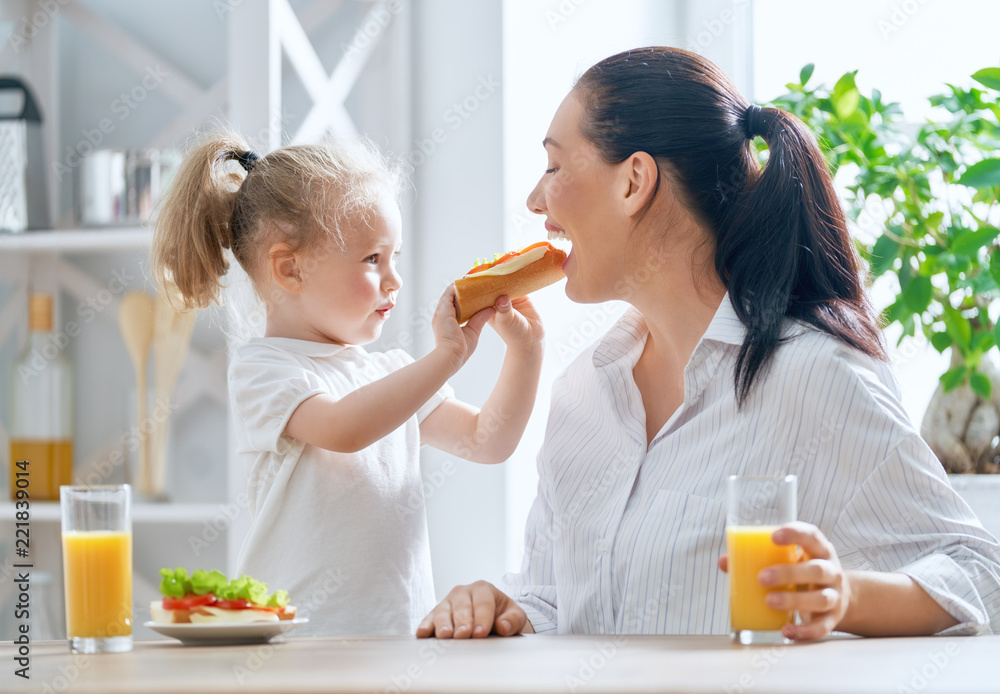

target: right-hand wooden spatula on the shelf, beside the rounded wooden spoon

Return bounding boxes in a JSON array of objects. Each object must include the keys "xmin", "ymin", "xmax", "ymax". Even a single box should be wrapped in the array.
[{"xmin": 148, "ymin": 295, "xmax": 195, "ymax": 498}]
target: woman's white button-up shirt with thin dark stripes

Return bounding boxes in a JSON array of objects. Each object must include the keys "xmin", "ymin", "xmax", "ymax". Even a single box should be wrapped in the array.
[{"xmin": 502, "ymin": 296, "xmax": 1000, "ymax": 634}]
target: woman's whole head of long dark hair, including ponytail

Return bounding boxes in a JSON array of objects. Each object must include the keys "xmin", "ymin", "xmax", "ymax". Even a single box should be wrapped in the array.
[{"xmin": 574, "ymin": 47, "xmax": 886, "ymax": 404}]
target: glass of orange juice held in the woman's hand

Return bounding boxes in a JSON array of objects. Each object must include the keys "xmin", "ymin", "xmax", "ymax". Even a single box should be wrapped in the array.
[{"xmin": 726, "ymin": 475, "xmax": 798, "ymax": 644}]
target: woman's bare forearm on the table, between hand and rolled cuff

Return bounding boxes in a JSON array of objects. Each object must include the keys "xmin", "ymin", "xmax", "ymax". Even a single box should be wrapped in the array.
[{"xmin": 837, "ymin": 571, "xmax": 958, "ymax": 636}]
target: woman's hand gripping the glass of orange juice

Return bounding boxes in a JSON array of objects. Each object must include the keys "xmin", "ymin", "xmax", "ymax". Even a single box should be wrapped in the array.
[{"xmin": 719, "ymin": 521, "xmax": 852, "ymax": 641}]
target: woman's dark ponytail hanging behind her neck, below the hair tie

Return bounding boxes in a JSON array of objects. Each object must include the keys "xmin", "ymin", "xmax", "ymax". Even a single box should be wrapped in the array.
[{"xmin": 715, "ymin": 105, "xmax": 884, "ymax": 401}]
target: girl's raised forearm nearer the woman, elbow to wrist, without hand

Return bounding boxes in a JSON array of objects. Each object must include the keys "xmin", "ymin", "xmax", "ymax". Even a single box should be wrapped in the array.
[{"xmin": 469, "ymin": 345, "xmax": 543, "ymax": 463}]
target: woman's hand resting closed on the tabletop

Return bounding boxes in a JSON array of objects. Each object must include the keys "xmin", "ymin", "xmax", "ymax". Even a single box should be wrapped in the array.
[{"xmin": 417, "ymin": 580, "xmax": 531, "ymax": 639}]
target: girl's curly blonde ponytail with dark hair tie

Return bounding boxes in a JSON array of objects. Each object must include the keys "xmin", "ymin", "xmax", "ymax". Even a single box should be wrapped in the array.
[{"xmin": 152, "ymin": 134, "xmax": 249, "ymax": 309}]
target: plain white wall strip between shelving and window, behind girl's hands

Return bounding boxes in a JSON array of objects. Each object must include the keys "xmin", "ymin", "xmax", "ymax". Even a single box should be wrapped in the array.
[{"xmin": 410, "ymin": 0, "xmax": 507, "ymax": 596}]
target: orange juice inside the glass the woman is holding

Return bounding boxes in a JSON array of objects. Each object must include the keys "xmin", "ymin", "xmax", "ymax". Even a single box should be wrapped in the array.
[{"xmin": 726, "ymin": 525, "xmax": 798, "ymax": 631}]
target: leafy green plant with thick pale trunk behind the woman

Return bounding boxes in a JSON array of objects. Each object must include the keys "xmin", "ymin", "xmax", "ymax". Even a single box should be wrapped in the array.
[{"xmin": 760, "ymin": 64, "xmax": 1000, "ymax": 473}]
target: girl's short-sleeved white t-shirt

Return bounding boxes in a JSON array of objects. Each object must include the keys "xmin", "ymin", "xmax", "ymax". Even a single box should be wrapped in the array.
[{"xmin": 229, "ymin": 338, "xmax": 454, "ymax": 634}]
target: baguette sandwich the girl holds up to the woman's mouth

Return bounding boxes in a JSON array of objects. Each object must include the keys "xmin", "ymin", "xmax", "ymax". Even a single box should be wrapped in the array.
[{"xmin": 455, "ymin": 241, "xmax": 566, "ymax": 324}]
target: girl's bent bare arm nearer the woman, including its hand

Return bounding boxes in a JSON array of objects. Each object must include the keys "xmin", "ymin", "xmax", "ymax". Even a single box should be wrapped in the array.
[{"xmin": 420, "ymin": 297, "xmax": 544, "ymax": 464}]
